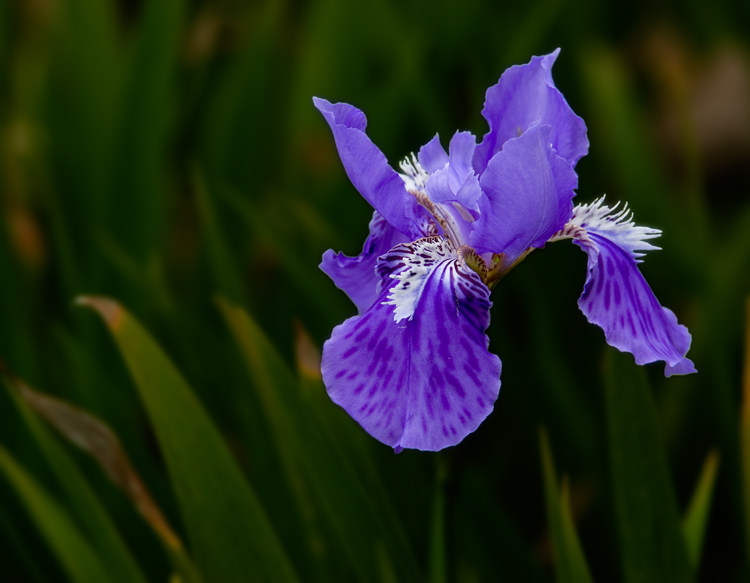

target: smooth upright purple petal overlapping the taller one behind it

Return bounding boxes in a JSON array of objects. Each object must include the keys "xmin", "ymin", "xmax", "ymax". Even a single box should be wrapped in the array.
[{"xmin": 471, "ymin": 125, "xmax": 578, "ymax": 261}]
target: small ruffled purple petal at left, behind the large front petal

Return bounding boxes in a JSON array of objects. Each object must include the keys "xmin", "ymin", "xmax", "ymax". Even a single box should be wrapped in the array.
[{"xmin": 320, "ymin": 211, "xmax": 408, "ymax": 314}]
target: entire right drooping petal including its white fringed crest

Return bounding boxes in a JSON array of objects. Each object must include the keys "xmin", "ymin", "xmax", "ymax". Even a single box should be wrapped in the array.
[{"xmin": 553, "ymin": 199, "xmax": 695, "ymax": 376}]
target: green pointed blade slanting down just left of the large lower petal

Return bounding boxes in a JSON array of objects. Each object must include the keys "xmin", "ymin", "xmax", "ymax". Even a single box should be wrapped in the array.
[{"xmin": 217, "ymin": 298, "xmax": 423, "ymax": 582}]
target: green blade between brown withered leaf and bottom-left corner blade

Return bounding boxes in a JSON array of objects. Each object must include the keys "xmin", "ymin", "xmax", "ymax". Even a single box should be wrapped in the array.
[{"xmin": 0, "ymin": 366, "xmax": 146, "ymax": 583}]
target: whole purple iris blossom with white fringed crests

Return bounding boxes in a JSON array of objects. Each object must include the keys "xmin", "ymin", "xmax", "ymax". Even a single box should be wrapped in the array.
[{"xmin": 313, "ymin": 49, "xmax": 695, "ymax": 451}]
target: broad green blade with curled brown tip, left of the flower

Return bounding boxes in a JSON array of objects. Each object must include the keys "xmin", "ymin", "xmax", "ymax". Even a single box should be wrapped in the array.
[{"xmin": 77, "ymin": 297, "xmax": 297, "ymax": 582}]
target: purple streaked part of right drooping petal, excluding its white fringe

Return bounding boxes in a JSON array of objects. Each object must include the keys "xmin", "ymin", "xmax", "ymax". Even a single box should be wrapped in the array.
[{"xmin": 575, "ymin": 231, "xmax": 695, "ymax": 376}]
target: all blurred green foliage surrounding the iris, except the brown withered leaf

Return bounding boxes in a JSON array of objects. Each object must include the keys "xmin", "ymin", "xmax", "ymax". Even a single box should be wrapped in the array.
[{"xmin": 0, "ymin": 0, "xmax": 750, "ymax": 583}]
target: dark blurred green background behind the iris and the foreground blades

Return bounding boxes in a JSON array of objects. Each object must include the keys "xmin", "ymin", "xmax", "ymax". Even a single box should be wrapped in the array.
[{"xmin": 0, "ymin": 0, "xmax": 750, "ymax": 581}]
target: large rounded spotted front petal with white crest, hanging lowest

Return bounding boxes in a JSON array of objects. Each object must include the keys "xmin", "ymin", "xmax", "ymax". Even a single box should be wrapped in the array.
[{"xmin": 322, "ymin": 237, "xmax": 501, "ymax": 451}]
